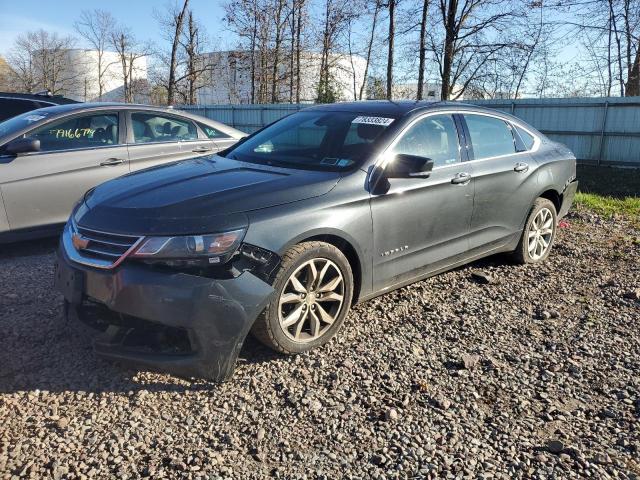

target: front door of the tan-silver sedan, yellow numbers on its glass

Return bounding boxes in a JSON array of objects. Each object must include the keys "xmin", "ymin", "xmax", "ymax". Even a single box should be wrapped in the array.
[{"xmin": 0, "ymin": 110, "xmax": 129, "ymax": 230}]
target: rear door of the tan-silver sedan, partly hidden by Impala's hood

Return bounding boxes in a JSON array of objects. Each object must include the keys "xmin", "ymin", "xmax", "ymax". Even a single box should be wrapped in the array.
[{"xmin": 128, "ymin": 111, "xmax": 216, "ymax": 171}]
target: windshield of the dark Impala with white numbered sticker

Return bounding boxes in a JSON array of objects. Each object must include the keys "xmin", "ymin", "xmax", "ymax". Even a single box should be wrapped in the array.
[{"xmin": 226, "ymin": 111, "xmax": 394, "ymax": 170}]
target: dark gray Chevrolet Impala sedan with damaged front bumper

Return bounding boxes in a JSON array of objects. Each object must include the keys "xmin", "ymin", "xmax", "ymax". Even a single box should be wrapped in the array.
[{"xmin": 56, "ymin": 102, "xmax": 577, "ymax": 380}]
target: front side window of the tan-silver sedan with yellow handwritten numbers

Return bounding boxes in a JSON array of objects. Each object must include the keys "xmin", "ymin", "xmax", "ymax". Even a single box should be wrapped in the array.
[{"xmin": 27, "ymin": 113, "xmax": 118, "ymax": 152}]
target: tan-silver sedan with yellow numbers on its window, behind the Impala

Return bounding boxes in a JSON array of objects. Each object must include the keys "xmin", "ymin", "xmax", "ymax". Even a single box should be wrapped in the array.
[{"xmin": 0, "ymin": 103, "xmax": 245, "ymax": 242}]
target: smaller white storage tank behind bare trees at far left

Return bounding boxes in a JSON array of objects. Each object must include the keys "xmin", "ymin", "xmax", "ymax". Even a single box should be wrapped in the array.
[{"xmin": 48, "ymin": 49, "xmax": 147, "ymax": 102}]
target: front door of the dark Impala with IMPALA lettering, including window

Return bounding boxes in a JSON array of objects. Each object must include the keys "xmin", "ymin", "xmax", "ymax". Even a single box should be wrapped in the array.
[{"xmin": 371, "ymin": 114, "xmax": 474, "ymax": 290}]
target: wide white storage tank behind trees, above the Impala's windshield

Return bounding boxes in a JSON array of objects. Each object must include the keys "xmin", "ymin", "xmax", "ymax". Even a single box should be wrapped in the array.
[{"xmin": 198, "ymin": 51, "xmax": 366, "ymax": 104}]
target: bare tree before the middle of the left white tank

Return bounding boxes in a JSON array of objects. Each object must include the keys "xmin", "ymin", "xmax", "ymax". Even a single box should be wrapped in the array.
[{"xmin": 74, "ymin": 9, "xmax": 116, "ymax": 100}]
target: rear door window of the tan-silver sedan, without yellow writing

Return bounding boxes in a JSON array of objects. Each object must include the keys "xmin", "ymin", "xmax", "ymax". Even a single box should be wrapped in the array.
[{"xmin": 131, "ymin": 113, "xmax": 198, "ymax": 143}]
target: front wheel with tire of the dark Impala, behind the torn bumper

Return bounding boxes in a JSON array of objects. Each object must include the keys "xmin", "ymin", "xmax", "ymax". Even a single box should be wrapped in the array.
[{"xmin": 252, "ymin": 242, "xmax": 353, "ymax": 354}]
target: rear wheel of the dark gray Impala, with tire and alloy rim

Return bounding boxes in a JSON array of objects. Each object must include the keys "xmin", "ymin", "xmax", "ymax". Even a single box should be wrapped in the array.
[{"xmin": 513, "ymin": 198, "xmax": 557, "ymax": 263}]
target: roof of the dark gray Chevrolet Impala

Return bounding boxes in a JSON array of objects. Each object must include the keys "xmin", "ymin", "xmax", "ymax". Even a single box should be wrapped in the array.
[{"xmin": 305, "ymin": 100, "xmax": 509, "ymax": 117}]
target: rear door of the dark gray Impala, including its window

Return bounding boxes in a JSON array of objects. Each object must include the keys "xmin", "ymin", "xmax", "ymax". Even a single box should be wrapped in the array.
[{"xmin": 462, "ymin": 113, "xmax": 537, "ymax": 249}]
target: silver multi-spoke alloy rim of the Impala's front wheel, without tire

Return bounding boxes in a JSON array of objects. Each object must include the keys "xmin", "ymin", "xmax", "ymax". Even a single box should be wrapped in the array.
[{"xmin": 278, "ymin": 258, "xmax": 345, "ymax": 342}]
